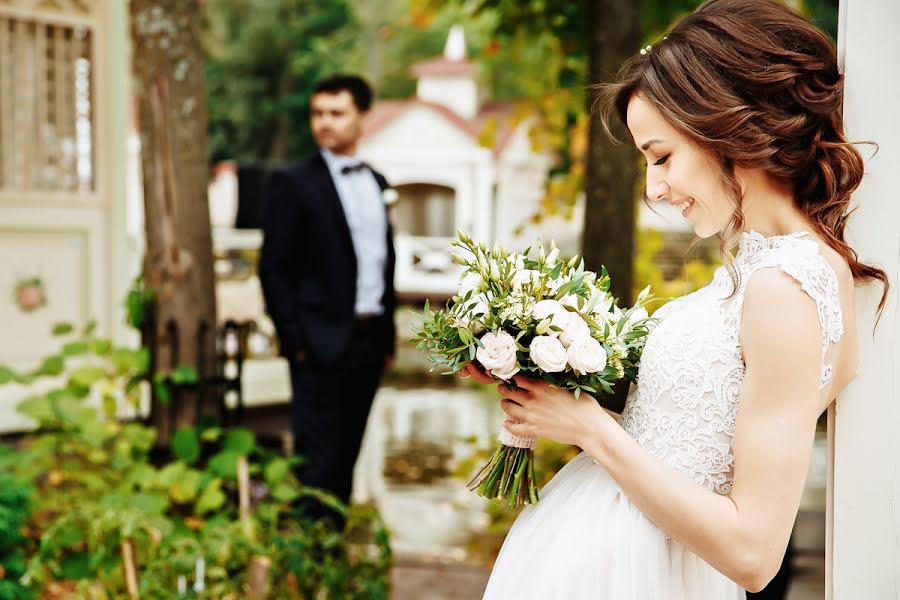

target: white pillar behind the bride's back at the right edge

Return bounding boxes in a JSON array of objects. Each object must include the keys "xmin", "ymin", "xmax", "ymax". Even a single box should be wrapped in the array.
[{"xmin": 826, "ymin": 0, "xmax": 900, "ymax": 600}]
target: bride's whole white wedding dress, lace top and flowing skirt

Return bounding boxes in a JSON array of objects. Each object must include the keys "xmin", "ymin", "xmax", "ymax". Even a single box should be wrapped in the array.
[{"xmin": 484, "ymin": 232, "xmax": 843, "ymax": 600}]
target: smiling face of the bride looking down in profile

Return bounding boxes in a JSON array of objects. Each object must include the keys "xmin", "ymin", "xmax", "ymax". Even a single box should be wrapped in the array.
[{"xmin": 628, "ymin": 94, "xmax": 735, "ymax": 238}]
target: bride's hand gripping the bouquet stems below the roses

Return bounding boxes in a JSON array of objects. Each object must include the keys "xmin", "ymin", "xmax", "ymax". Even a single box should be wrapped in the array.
[{"xmin": 497, "ymin": 375, "xmax": 615, "ymax": 447}]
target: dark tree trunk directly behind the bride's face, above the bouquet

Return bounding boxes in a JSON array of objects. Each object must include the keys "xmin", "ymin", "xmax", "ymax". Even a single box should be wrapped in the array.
[{"xmin": 582, "ymin": 0, "xmax": 641, "ymax": 303}]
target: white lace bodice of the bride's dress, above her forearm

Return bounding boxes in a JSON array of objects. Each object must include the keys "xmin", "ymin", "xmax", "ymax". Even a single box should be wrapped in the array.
[{"xmin": 622, "ymin": 231, "xmax": 843, "ymax": 494}]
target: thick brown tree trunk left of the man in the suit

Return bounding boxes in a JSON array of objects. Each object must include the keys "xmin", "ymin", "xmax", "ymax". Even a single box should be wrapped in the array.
[{"xmin": 131, "ymin": 0, "xmax": 216, "ymax": 445}]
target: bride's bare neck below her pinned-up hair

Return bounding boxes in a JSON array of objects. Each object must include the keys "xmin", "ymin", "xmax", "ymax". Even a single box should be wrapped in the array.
[{"xmin": 740, "ymin": 171, "xmax": 812, "ymax": 237}]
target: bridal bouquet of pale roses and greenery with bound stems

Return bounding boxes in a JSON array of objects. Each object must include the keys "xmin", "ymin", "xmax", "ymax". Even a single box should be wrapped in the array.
[{"xmin": 413, "ymin": 231, "xmax": 655, "ymax": 506}]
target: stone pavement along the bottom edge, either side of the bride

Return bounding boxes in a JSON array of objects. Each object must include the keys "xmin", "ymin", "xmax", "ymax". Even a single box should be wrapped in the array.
[{"xmin": 392, "ymin": 555, "xmax": 825, "ymax": 600}]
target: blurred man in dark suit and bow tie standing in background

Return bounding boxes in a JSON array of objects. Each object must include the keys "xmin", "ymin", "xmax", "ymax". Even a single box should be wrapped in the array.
[{"xmin": 259, "ymin": 75, "xmax": 396, "ymax": 528}]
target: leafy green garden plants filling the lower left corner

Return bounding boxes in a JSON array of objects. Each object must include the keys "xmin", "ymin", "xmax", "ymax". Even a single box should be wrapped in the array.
[{"xmin": 0, "ymin": 325, "xmax": 391, "ymax": 600}]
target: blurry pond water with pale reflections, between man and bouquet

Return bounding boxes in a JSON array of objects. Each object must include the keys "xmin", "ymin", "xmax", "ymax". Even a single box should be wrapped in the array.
[{"xmin": 354, "ymin": 387, "xmax": 502, "ymax": 556}]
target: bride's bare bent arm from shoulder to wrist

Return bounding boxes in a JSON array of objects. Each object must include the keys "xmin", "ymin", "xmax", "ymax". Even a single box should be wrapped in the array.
[{"xmin": 583, "ymin": 270, "xmax": 822, "ymax": 591}]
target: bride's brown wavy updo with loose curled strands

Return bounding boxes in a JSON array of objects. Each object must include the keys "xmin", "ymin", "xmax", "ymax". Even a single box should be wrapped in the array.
[{"xmin": 596, "ymin": 0, "xmax": 889, "ymax": 314}]
